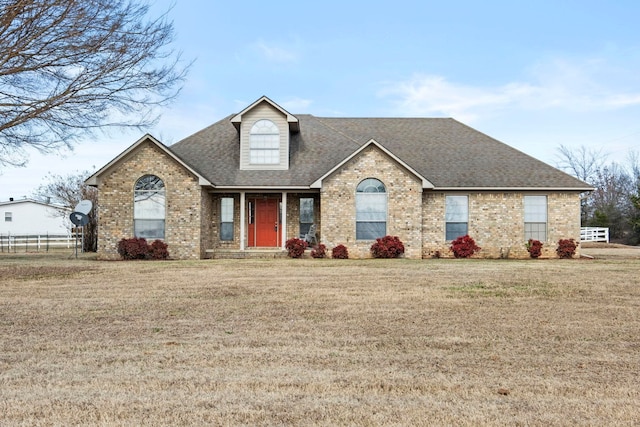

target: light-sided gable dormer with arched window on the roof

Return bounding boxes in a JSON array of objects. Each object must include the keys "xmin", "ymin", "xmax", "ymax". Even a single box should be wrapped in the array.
[{"xmin": 231, "ymin": 96, "xmax": 299, "ymax": 170}]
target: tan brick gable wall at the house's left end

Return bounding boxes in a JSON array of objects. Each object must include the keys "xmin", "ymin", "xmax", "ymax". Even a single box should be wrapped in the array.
[{"xmin": 98, "ymin": 141, "xmax": 202, "ymax": 259}]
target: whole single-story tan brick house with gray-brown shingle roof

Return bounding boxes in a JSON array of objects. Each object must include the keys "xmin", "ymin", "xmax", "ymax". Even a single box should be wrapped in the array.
[{"xmin": 86, "ymin": 97, "xmax": 591, "ymax": 259}]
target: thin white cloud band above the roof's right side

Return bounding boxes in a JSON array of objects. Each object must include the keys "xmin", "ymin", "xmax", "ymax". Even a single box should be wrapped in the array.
[{"xmin": 379, "ymin": 56, "xmax": 640, "ymax": 122}]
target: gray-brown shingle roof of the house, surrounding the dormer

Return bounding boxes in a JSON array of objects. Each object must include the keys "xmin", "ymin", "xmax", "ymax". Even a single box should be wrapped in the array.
[{"xmin": 169, "ymin": 114, "xmax": 590, "ymax": 190}]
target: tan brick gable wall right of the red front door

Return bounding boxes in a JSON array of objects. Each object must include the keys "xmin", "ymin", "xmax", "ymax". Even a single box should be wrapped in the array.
[{"xmin": 320, "ymin": 146, "xmax": 423, "ymax": 258}]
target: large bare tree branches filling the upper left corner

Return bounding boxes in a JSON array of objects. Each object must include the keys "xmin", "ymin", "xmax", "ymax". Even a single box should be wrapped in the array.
[{"xmin": 0, "ymin": 0, "xmax": 189, "ymax": 166}]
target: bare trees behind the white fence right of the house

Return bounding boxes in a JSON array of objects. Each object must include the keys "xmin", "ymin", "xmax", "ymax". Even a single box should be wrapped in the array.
[{"xmin": 558, "ymin": 145, "xmax": 640, "ymax": 245}]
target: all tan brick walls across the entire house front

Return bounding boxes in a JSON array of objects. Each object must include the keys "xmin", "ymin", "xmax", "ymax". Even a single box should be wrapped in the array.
[{"xmin": 98, "ymin": 142, "xmax": 580, "ymax": 259}]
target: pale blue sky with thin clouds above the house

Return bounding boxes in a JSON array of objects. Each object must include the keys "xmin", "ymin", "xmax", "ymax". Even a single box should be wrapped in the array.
[{"xmin": 0, "ymin": 0, "xmax": 640, "ymax": 201}]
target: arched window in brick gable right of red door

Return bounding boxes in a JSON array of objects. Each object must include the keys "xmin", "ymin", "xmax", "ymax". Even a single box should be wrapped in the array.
[{"xmin": 356, "ymin": 178, "xmax": 387, "ymax": 240}]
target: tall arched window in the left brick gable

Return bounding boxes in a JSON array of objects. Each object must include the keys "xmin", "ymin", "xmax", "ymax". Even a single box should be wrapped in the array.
[{"xmin": 133, "ymin": 175, "xmax": 166, "ymax": 240}]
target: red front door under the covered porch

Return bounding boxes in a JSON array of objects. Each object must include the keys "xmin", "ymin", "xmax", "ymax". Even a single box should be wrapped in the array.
[{"xmin": 248, "ymin": 199, "xmax": 280, "ymax": 248}]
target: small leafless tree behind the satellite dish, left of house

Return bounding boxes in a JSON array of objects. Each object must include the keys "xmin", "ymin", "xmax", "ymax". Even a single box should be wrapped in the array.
[{"xmin": 34, "ymin": 171, "xmax": 100, "ymax": 252}]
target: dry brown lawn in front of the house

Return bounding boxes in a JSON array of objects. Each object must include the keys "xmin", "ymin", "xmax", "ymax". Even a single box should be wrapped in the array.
[{"xmin": 0, "ymin": 254, "xmax": 640, "ymax": 426}]
